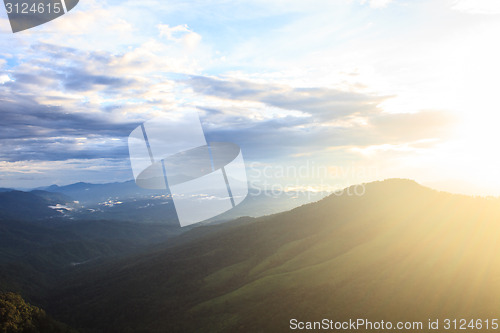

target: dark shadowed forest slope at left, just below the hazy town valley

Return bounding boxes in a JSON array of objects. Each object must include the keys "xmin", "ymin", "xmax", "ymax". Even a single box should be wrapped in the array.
[{"xmin": 0, "ymin": 220, "xmax": 180, "ymax": 299}]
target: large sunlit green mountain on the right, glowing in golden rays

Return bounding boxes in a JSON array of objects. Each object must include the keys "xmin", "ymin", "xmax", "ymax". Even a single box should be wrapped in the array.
[{"xmin": 44, "ymin": 179, "xmax": 500, "ymax": 332}]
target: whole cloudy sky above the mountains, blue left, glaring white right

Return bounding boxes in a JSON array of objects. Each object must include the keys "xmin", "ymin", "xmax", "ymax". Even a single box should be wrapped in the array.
[{"xmin": 0, "ymin": 0, "xmax": 500, "ymax": 195}]
